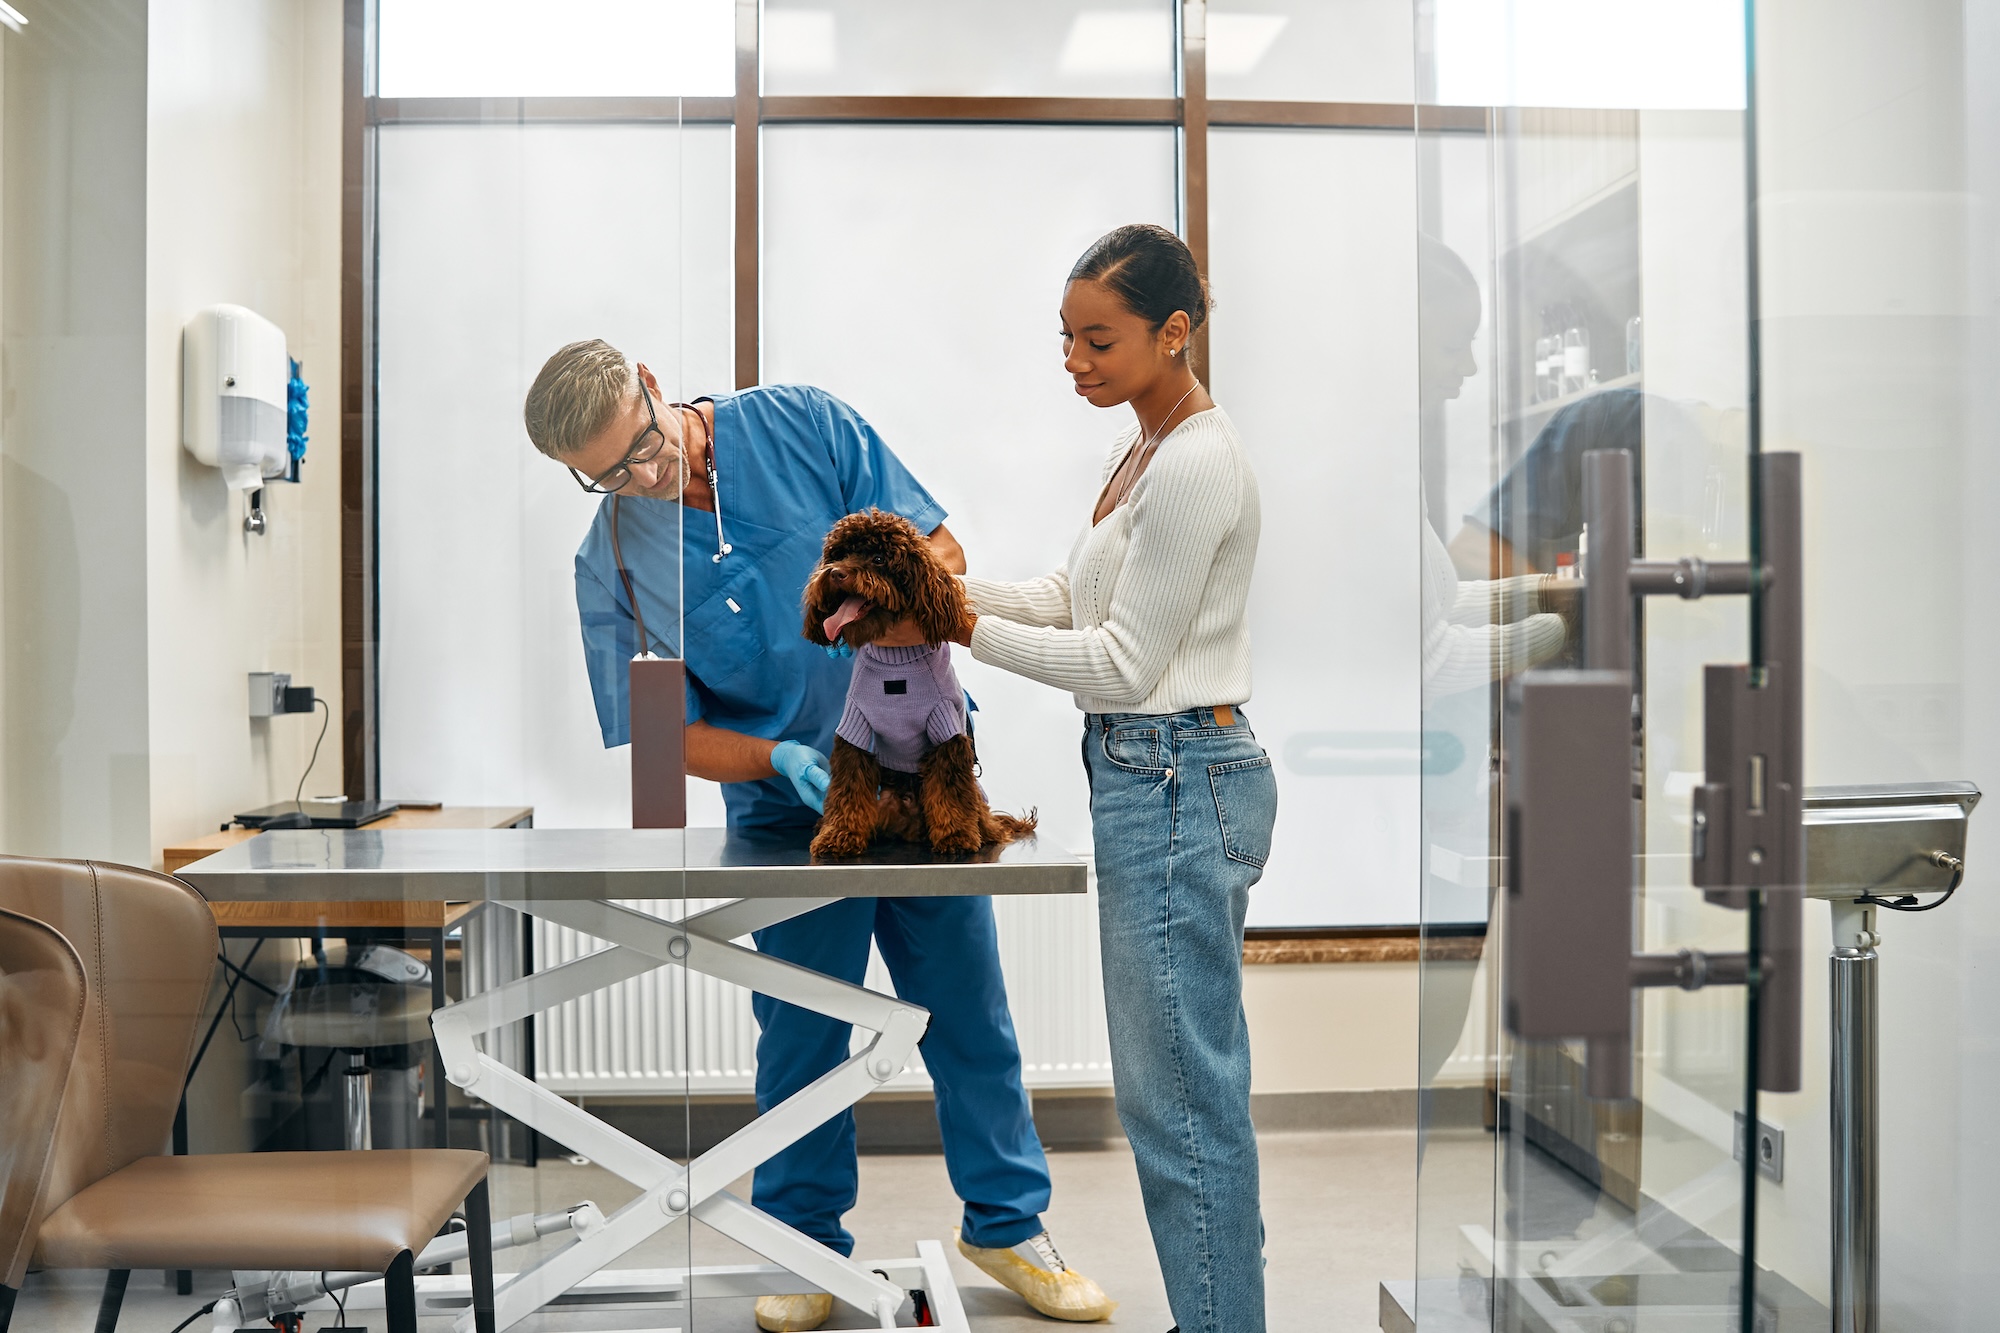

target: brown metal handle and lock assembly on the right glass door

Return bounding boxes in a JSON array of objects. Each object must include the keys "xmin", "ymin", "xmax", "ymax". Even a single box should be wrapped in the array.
[{"xmin": 1506, "ymin": 450, "xmax": 1806, "ymax": 1097}]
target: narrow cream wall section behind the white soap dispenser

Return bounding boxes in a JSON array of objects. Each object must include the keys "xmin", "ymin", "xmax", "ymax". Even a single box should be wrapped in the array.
[{"xmin": 144, "ymin": 0, "xmax": 342, "ymax": 857}]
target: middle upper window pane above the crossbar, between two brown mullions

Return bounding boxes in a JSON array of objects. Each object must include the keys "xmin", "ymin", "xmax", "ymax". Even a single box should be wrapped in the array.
[{"xmin": 762, "ymin": 0, "xmax": 1168, "ymax": 98}]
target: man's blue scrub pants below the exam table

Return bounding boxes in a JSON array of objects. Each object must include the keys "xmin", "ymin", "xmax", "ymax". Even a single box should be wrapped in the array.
[{"xmin": 750, "ymin": 897, "xmax": 1048, "ymax": 1255}]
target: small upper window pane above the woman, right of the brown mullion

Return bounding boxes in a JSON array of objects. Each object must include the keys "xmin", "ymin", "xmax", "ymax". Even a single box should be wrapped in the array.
[{"xmin": 1208, "ymin": 0, "xmax": 1412, "ymax": 102}]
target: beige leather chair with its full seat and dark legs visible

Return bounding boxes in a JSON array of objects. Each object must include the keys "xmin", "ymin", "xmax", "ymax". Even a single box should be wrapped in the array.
[{"xmin": 0, "ymin": 857, "xmax": 494, "ymax": 1333}]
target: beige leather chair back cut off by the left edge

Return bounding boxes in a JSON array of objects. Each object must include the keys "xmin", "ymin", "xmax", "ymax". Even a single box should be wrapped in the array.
[{"xmin": 0, "ymin": 911, "xmax": 84, "ymax": 1329}]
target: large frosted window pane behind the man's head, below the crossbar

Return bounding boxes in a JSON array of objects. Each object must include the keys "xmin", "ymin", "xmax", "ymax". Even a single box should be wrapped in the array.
[{"xmin": 376, "ymin": 126, "xmax": 732, "ymax": 827}]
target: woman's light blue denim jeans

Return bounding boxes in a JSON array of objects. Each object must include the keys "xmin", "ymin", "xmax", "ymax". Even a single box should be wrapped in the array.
[{"xmin": 1084, "ymin": 709, "xmax": 1278, "ymax": 1333}]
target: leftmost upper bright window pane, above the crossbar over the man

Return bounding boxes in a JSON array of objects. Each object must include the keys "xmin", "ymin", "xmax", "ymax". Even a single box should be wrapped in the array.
[{"xmin": 376, "ymin": 0, "xmax": 736, "ymax": 98}]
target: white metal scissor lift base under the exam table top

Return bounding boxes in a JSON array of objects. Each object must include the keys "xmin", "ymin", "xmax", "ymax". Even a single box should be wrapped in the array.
[{"xmin": 236, "ymin": 899, "xmax": 970, "ymax": 1333}]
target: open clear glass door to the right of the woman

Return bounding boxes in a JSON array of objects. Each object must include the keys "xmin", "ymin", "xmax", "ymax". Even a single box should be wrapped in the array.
[{"xmin": 1412, "ymin": 4, "xmax": 1798, "ymax": 1331}]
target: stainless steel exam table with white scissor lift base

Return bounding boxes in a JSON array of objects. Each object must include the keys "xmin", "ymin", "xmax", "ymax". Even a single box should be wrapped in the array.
[{"xmin": 180, "ymin": 829, "xmax": 1086, "ymax": 1333}]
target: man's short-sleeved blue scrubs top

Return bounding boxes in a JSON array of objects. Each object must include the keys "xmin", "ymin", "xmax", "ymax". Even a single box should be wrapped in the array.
[{"xmin": 576, "ymin": 384, "xmax": 944, "ymax": 829}]
